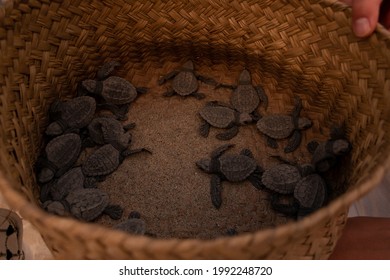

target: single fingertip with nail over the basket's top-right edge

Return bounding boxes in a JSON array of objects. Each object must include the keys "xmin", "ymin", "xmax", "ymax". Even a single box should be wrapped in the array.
[{"xmin": 352, "ymin": 0, "xmax": 382, "ymax": 37}]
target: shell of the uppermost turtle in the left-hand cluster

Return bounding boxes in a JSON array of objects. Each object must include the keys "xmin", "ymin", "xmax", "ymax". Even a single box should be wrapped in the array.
[{"xmin": 101, "ymin": 76, "xmax": 137, "ymax": 105}]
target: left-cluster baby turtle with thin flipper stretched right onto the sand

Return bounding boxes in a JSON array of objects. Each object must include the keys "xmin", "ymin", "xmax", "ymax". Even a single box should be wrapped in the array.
[{"xmin": 81, "ymin": 144, "xmax": 150, "ymax": 188}]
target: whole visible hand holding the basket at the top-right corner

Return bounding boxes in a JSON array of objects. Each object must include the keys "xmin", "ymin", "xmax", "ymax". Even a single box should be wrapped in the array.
[{"xmin": 340, "ymin": 0, "xmax": 390, "ymax": 37}]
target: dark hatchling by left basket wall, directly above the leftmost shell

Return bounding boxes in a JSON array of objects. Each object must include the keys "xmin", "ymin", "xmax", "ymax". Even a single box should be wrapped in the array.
[{"xmin": 46, "ymin": 96, "xmax": 96, "ymax": 136}]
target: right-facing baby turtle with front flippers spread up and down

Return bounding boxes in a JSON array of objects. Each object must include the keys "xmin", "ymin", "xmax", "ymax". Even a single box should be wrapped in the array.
[{"xmin": 257, "ymin": 97, "xmax": 312, "ymax": 153}]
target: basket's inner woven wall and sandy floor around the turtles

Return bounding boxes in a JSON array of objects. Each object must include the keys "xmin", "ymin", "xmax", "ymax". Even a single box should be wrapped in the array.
[{"xmin": 0, "ymin": 1, "xmax": 390, "ymax": 249}]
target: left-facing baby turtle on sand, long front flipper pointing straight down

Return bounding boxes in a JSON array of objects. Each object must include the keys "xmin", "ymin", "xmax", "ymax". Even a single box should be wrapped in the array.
[{"xmin": 196, "ymin": 144, "xmax": 263, "ymax": 209}]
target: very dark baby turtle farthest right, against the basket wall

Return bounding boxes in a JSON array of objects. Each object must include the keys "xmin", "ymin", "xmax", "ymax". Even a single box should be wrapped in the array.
[{"xmin": 307, "ymin": 127, "xmax": 352, "ymax": 173}]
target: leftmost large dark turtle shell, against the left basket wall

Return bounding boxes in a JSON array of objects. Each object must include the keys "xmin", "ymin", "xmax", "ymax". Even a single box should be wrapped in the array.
[{"xmin": 45, "ymin": 133, "xmax": 81, "ymax": 169}]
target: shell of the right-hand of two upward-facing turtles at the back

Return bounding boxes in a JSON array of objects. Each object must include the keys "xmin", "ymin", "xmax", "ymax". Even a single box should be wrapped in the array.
[{"xmin": 230, "ymin": 85, "xmax": 260, "ymax": 114}]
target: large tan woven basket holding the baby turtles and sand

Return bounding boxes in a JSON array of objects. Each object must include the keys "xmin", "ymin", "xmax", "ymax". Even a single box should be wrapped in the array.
[{"xmin": 0, "ymin": 0, "xmax": 390, "ymax": 259}]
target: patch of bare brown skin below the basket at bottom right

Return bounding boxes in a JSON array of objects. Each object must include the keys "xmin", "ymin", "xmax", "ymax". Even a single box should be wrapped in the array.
[{"xmin": 329, "ymin": 217, "xmax": 390, "ymax": 260}]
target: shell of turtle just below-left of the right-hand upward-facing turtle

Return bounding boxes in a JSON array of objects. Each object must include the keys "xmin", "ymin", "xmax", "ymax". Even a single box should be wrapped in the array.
[{"xmin": 199, "ymin": 106, "xmax": 235, "ymax": 128}]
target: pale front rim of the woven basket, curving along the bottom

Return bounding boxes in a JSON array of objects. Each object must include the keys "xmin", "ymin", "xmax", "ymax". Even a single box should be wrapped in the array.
[{"xmin": 0, "ymin": 158, "xmax": 390, "ymax": 256}]
